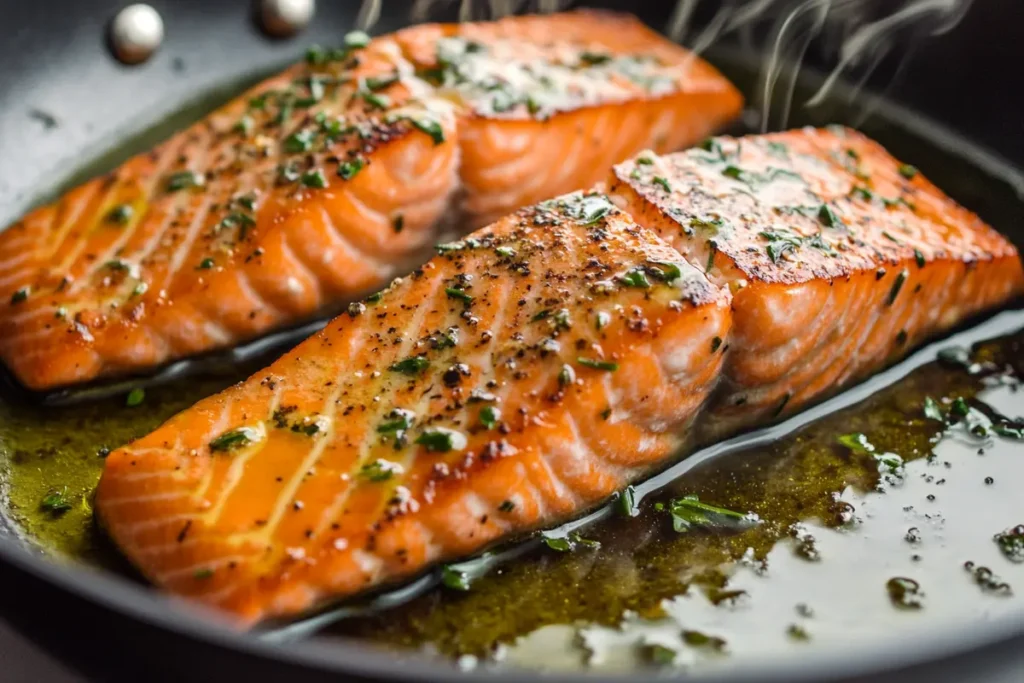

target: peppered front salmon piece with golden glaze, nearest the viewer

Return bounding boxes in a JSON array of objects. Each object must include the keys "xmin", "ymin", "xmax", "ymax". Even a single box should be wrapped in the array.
[{"xmin": 96, "ymin": 194, "xmax": 731, "ymax": 625}]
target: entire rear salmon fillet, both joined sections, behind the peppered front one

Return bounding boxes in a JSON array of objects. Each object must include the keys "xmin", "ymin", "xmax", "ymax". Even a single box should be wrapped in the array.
[{"xmin": 0, "ymin": 11, "xmax": 741, "ymax": 390}]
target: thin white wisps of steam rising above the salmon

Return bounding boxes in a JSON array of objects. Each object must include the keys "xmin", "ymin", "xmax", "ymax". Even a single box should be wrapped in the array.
[{"xmin": 358, "ymin": 0, "xmax": 973, "ymax": 130}]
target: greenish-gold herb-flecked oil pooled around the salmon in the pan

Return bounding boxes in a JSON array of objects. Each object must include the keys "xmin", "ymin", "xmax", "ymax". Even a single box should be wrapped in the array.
[{"xmin": 0, "ymin": 42, "xmax": 1024, "ymax": 670}]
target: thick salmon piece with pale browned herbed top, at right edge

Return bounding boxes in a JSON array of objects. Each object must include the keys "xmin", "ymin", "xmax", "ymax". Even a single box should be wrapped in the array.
[{"xmin": 608, "ymin": 128, "xmax": 1024, "ymax": 433}]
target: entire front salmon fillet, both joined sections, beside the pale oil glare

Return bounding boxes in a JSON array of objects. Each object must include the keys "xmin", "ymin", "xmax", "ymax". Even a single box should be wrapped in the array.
[{"xmin": 96, "ymin": 125, "xmax": 1024, "ymax": 626}]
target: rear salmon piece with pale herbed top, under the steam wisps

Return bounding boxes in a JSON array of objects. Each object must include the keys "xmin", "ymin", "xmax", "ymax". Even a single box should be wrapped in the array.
[{"xmin": 395, "ymin": 11, "xmax": 742, "ymax": 226}]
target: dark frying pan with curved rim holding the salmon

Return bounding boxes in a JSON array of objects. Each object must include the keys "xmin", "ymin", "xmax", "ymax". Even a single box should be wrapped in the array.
[{"xmin": 0, "ymin": 0, "xmax": 1024, "ymax": 683}]
